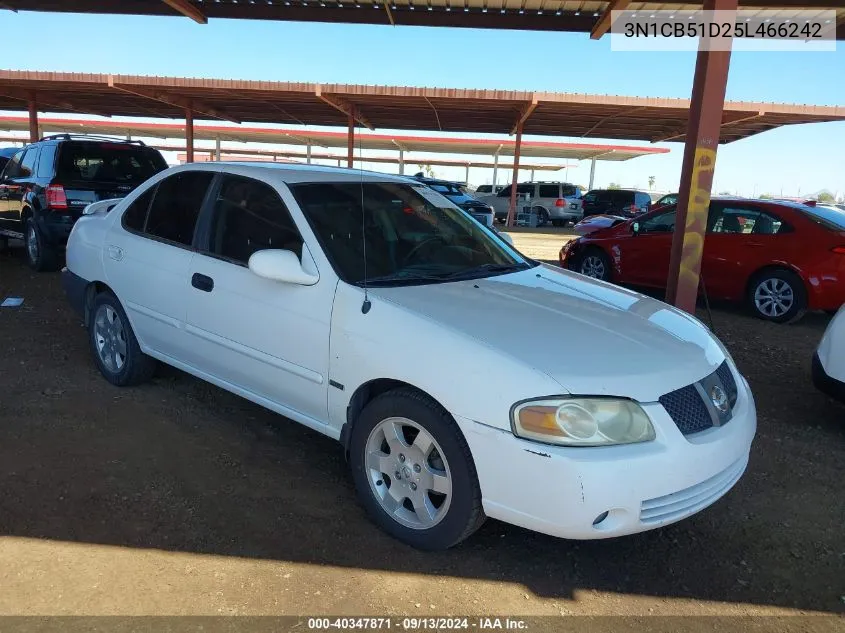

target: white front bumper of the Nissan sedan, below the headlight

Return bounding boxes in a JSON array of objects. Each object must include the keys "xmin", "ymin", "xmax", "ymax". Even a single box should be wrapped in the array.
[{"xmin": 458, "ymin": 380, "xmax": 757, "ymax": 539}]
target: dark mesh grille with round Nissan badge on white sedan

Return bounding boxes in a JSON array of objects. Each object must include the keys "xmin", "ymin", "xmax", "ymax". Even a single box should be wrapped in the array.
[{"xmin": 658, "ymin": 361, "xmax": 738, "ymax": 435}]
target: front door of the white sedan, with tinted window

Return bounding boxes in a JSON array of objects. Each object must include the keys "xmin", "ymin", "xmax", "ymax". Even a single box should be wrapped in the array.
[{"xmin": 186, "ymin": 175, "xmax": 336, "ymax": 424}]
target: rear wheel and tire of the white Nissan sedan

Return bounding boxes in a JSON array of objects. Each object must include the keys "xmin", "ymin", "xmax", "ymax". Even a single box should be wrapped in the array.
[{"xmin": 88, "ymin": 292, "xmax": 156, "ymax": 387}]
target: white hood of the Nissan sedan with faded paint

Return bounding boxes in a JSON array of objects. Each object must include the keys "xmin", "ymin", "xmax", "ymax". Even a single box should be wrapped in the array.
[{"xmin": 370, "ymin": 265, "xmax": 725, "ymax": 402}]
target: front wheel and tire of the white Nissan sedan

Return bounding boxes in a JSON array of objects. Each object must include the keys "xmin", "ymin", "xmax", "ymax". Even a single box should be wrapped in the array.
[{"xmin": 349, "ymin": 389, "xmax": 485, "ymax": 551}]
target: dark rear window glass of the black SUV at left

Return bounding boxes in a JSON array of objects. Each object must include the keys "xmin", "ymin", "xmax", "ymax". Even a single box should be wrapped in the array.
[{"xmin": 56, "ymin": 143, "xmax": 167, "ymax": 185}]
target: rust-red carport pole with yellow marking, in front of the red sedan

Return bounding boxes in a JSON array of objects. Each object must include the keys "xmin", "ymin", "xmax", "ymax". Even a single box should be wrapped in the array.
[{"xmin": 666, "ymin": 0, "xmax": 737, "ymax": 314}]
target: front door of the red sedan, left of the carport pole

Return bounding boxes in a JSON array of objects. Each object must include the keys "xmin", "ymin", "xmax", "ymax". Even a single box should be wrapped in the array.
[{"xmin": 619, "ymin": 207, "xmax": 675, "ymax": 288}]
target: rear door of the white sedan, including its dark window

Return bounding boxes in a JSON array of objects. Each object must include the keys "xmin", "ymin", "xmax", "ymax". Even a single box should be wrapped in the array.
[{"xmin": 103, "ymin": 171, "xmax": 214, "ymax": 364}]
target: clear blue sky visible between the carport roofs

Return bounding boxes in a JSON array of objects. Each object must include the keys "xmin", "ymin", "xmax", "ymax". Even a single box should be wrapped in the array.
[{"xmin": 0, "ymin": 9, "xmax": 845, "ymax": 195}]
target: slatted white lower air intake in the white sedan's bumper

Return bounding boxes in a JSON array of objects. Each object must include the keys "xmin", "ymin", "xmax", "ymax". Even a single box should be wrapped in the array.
[{"xmin": 640, "ymin": 455, "xmax": 748, "ymax": 525}]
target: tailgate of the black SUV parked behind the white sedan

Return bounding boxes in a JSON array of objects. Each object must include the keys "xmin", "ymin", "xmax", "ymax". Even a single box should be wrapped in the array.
[{"xmin": 54, "ymin": 141, "xmax": 167, "ymax": 216}]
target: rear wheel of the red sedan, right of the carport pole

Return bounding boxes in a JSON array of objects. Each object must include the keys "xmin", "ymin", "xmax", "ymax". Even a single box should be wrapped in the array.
[{"xmin": 747, "ymin": 268, "xmax": 807, "ymax": 323}]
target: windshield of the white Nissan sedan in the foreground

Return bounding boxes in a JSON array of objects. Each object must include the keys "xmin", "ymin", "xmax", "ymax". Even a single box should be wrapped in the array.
[{"xmin": 290, "ymin": 182, "xmax": 536, "ymax": 286}]
